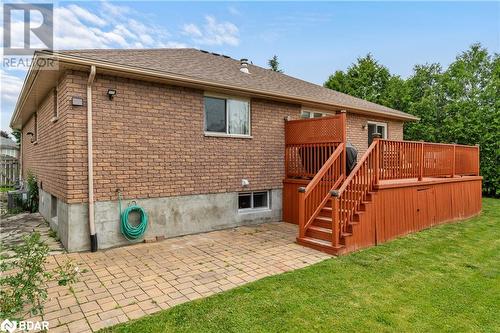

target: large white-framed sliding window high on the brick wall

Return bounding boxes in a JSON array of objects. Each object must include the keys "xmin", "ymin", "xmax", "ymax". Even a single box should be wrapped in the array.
[{"xmin": 205, "ymin": 96, "xmax": 250, "ymax": 136}]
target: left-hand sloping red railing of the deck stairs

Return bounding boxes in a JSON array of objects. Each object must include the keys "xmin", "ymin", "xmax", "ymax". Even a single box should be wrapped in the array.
[{"xmin": 299, "ymin": 143, "xmax": 345, "ymax": 238}]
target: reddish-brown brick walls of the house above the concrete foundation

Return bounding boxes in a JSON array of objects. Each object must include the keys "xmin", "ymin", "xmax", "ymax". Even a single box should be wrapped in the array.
[{"xmin": 23, "ymin": 71, "xmax": 403, "ymax": 203}]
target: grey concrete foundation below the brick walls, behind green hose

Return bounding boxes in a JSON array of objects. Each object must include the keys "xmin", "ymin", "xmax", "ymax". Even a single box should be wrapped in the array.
[{"xmin": 39, "ymin": 189, "xmax": 282, "ymax": 252}]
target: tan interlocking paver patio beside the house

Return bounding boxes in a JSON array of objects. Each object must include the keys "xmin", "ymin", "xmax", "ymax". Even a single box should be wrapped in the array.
[{"xmin": 27, "ymin": 223, "xmax": 330, "ymax": 332}]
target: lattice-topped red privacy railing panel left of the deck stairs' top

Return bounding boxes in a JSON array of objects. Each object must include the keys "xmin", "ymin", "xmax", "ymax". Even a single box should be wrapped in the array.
[{"xmin": 285, "ymin": 113, "xmax": 345, "ymax": 179}]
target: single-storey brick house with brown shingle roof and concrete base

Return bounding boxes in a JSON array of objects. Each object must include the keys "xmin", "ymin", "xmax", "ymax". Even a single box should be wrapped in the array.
[{"xmin": 11, "ymin": 49, "xmax": 416, "ymax": 251}]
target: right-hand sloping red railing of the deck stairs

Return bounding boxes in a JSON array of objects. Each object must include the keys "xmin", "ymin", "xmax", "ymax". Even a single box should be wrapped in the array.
[{"xmin": 330, "ymin": 139, "xmax": 380, "ymax": 240}]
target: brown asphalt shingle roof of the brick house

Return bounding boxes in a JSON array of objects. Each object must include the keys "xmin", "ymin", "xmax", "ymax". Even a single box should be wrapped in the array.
[{"xmin": 59, "ymin": 48, "xmax": 415, "ymax": 119}]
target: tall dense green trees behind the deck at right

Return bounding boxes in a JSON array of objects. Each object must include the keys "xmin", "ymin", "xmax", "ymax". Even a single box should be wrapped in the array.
[{"xmin": 325, "ymin": 44, "xmax": 500, "ymax": 196}]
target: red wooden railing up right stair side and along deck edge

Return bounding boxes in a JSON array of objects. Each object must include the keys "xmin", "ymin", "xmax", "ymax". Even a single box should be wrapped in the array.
[{"xmin": 332, "ymin": 139, "xmax": 479, "ymax": 246}]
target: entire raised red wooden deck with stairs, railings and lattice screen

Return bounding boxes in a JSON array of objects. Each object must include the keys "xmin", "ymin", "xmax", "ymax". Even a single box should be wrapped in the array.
[{"xmin": 283, "ymin": 115, "xmax": 482, "ymax": 254}]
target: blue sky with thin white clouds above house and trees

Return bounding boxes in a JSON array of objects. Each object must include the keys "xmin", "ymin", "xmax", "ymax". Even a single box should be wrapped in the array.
[{"xmin": 0, "ymin": 0, "xmax": 500, "ymax": 131}]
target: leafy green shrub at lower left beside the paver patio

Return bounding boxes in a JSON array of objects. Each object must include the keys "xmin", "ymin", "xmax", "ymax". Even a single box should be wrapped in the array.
[{"xmin": 0, "ymin": 232, "xmax": 79, "ymax": 320}]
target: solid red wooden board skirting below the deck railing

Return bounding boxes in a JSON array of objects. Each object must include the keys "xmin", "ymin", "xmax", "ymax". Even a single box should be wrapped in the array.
[{"xmin": 344, "ymin": 176, "xmax": 482, "ymax": 252}]
